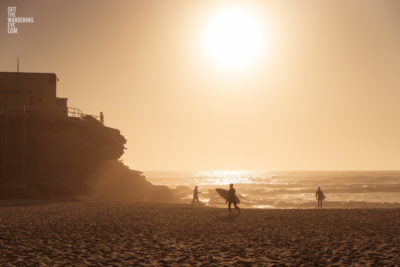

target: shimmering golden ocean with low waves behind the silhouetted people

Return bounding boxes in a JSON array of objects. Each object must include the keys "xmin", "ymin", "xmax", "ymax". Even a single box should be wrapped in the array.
[{"xmin": 144, "ymin": 171, "xmax": 400, "ymax": 208}]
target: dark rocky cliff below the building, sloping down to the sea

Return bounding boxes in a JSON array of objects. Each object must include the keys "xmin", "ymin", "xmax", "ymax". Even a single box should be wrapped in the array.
[{"xmin": 0, "ymin": 116, "xmax": 172, "ymax": 201}]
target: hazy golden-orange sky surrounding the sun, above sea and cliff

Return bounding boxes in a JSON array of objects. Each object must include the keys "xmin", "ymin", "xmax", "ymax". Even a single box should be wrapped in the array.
[{"xmin": 0, "ymin": 0, "xmax": 400, "ymax": 170}]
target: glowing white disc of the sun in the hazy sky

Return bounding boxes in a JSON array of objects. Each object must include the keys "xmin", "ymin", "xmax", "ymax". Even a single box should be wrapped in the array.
[{"xmin": 203, "ymin": 7, "xmax": 266, "ymax": 70}]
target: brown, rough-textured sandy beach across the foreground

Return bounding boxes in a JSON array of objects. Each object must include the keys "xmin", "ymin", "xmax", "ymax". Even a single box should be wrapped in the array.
[{"xmin": 0, "ymin": 201, "xmax": 400, "ymax": 266}]
